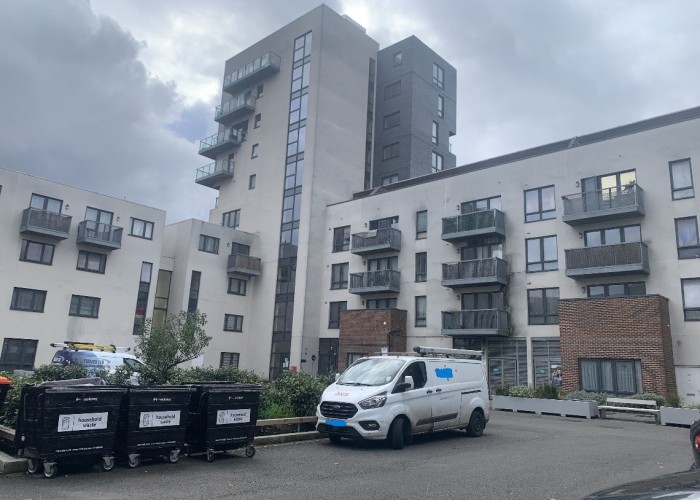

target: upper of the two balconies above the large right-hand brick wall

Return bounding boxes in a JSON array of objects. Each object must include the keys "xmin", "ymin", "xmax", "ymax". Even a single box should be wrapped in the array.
[{"xmin": 562, "ymin": 184, "xmax": 644, "ymax": 226}]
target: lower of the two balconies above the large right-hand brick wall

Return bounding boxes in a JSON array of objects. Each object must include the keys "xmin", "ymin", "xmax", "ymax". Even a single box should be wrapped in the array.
[{"xmin": 564, "ymin": 242, "xmax": 649, "ymax": 278}]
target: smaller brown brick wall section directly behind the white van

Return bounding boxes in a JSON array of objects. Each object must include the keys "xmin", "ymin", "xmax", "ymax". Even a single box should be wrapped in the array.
[{"xmin": 338, "ymin": 309, "xmax": 406, "ymax": 372}]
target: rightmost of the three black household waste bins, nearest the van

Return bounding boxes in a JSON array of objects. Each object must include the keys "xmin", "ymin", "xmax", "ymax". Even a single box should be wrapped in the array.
[{"xmin": 186, "ymin": 382, "xmax": 262, "ymax": 462}]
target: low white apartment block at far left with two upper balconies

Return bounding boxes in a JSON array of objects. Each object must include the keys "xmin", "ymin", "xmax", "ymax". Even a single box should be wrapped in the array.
[{"xmin": 0, "ymin": 168, "xmax": 165, "ymax": 371}]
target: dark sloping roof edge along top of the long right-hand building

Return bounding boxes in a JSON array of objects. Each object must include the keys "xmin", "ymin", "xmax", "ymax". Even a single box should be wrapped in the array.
[{"xmin": 353, "ymin": 106, "xmax": 700, "ymax": 200}]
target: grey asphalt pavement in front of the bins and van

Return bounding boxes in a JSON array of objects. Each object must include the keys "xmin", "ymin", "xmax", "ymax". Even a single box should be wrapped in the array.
[{"xmin": 0, "ymin": 412, "xmax": 692, "ymax": 500}]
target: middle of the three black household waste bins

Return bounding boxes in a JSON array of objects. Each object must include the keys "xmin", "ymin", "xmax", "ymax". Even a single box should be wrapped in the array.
[{"xmin": 115, "ymin": 385, "xmax": 194, "ymax": 468}]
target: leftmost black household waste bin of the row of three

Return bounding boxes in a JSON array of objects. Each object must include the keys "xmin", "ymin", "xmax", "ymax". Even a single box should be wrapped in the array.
[{"xmin": 15, "ymin": 385, "xmax": 126, "ymax": 478}]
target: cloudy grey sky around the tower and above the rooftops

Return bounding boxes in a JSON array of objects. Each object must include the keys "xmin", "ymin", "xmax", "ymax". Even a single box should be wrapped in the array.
[{"xmin": 0, "ymin": 0, "xmax": 700, "ymax": 222}]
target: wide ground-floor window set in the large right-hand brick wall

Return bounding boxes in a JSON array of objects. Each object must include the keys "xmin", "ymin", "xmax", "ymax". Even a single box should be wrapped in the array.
[{"xmin": 579, "ymin": 359, "xmax": 643, "ymax": 394}]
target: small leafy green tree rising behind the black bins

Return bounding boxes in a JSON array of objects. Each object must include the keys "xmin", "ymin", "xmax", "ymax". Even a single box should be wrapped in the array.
[{"xmin": 135, "ymin": 311, "xmax": 211, "ymax": 384}]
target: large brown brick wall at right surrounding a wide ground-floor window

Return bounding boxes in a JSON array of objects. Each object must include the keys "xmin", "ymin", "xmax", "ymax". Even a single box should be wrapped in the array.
[{"xmin": 559, "ymin": 295, "xmax": 676, "ymax": 396}]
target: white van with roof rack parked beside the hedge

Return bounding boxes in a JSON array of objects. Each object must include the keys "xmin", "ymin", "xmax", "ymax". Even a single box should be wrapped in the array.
[{"xmin": 316, "ymin": 347, "xmax": 489, "ymax": 449}]
